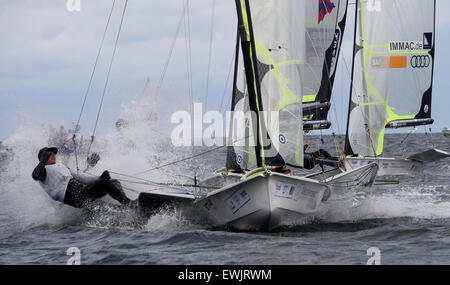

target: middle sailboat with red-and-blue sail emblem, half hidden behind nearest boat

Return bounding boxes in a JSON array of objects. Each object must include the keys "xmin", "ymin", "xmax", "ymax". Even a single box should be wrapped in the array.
[{"xmin": 296, "ymin": 0, "xmax": 378, "ymax": 194}]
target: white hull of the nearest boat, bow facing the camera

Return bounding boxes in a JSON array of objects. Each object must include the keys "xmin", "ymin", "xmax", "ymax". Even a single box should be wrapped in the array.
[{"xmin": 194, "ymin": 171, "xmax": 328, "ymax": 230}]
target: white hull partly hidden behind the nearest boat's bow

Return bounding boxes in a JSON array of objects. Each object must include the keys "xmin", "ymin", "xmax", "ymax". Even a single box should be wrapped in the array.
[{"xmin": 306, "ymin": 163, "xmax": 378, "ymax": 196}]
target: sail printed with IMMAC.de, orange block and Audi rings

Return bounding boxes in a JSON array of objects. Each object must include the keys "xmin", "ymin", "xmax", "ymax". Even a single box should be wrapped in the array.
[{"xmin": 345, "ymin": 0, "xmax": 435, "ymax": 156}]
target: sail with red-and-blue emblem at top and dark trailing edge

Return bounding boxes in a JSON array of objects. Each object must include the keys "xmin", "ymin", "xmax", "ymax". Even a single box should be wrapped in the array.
[{"xmin": 301, "ymin": 0, "xmax": 348, "ymax": 124}]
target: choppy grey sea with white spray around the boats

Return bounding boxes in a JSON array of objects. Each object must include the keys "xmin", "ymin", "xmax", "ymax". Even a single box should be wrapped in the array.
[{"xmin": 0, "ymin": 115, "xmax": 450, "ymax": 265}]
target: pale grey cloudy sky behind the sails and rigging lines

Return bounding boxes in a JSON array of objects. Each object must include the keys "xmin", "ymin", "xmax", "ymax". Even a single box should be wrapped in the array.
[{"xmin": 0, "ymin": 0, "xmax": 450, "ymax": 140}]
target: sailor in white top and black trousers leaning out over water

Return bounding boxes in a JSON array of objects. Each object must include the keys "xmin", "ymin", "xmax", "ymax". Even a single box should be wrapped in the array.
[{"xmin": 32, "ymin": 147, "xmax": 137, "ymax": 208}]
